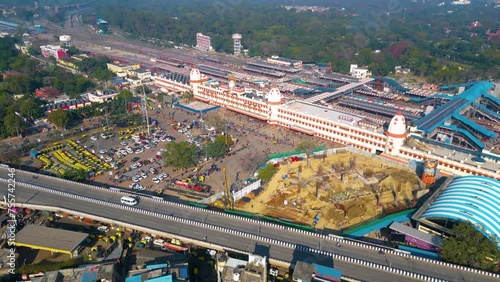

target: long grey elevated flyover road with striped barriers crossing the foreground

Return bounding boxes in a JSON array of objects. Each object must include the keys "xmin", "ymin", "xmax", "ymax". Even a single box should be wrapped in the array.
[{"xmin": 0, "ymin": 168, "xmax": 498, "ymax": 281}]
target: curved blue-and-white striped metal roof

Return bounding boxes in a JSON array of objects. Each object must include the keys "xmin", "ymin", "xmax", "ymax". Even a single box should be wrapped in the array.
[{"xmin": 421, "ymin": 176, "xmax": 500, "ymax": 248}]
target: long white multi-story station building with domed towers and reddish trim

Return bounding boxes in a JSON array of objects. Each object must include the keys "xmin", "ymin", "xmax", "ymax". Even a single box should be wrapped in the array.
[{"xmin": 190, "ymin": 67, "xmax": 500, "ymax": 179}]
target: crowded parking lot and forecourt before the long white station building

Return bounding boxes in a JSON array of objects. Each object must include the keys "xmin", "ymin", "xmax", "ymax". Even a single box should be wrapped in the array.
[{"xmin": 27, "ymin": 97, "xmax": 332, "ymax": 200}]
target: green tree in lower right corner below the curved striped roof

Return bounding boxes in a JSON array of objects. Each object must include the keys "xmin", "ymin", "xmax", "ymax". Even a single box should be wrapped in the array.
[{"xmin": 441, "ymin": 222, "xmax": 500, "ymax": 271}]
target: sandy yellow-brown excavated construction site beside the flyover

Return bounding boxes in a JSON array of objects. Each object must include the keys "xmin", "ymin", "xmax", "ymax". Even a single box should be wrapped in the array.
[{"xmin": 234, "ymin": 150, "xmax": 426, "ymax": 230}]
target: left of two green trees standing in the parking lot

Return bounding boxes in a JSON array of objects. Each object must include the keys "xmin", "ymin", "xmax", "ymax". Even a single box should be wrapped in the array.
[{"xmin": 163, "ymin": 141, "xmax": 198, "ymax": 168}]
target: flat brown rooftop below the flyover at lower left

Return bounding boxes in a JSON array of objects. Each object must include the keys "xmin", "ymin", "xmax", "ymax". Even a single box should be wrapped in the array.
[{"xmin": 16, "ymin": 225, "xmax": 89, "ymax": 253}]
